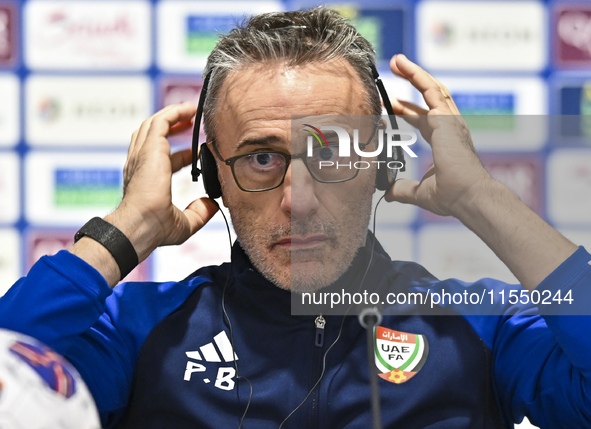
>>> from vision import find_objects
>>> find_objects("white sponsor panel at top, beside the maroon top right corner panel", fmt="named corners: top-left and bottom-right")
top-left (417, 1), bottom-right (546, 71)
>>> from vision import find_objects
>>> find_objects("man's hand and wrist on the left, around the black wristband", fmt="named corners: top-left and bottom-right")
top-left (69, 102), bottom-right (219, 286)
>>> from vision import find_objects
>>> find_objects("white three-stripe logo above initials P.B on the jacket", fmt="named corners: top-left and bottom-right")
top-left (184, 331), bottom-right (238, 390)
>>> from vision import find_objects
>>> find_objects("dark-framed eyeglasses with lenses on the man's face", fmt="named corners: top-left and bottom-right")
top-left (212, 125), bottom-right (378, 192)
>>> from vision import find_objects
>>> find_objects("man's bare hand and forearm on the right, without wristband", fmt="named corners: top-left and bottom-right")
top-left (386, 55), bottom-right (577, 290)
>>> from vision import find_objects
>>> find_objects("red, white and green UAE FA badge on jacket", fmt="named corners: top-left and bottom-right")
top-left (374, 326), bottom-right (429, 384)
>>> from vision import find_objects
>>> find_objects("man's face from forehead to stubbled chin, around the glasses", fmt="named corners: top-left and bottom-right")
top-left (216, 60), bottom-right (375, 292)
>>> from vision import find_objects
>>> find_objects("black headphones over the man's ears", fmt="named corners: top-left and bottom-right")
top-left (191, 62), bottom-right (406, 199)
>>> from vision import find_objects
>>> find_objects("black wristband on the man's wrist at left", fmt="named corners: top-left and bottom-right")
top-left (74, 217), bottom-right (139, 279)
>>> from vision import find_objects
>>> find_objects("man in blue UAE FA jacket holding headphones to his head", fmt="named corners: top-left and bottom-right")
top-left (0, 8), bottom-right (591, 428)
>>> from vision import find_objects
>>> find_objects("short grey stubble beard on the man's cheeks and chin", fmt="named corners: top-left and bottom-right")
top-left (221, 162), bottom-right (375, 293)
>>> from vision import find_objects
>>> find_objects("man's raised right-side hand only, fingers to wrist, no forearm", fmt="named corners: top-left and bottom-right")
top-left (386, 55), bottom-right (492, 216)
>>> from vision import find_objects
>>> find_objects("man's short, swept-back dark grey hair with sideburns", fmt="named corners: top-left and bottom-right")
top-left (203, 7), bottom-right (381, 140)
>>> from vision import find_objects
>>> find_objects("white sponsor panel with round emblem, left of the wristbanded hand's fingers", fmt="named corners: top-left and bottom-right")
top-left (26, 75), bottom-right (152, 146)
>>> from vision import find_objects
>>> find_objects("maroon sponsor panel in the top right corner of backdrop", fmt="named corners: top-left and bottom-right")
top-left (554, 5), bottom-right (591, 66)
